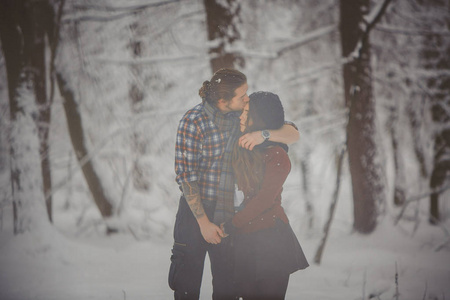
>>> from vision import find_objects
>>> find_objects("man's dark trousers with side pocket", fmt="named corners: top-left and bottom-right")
top-left (169, 197), bottom-right (237, 300)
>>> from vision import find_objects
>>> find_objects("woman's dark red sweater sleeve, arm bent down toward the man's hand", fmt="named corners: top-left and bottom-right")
top-left (232, 147), bottom-right (291, 228)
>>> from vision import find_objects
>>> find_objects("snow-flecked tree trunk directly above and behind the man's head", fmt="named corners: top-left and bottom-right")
top-left (204, 0), bottom-right (245, 72)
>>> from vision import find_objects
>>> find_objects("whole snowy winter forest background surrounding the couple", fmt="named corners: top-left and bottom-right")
top-left (0, 0), bottom-right (450, 300)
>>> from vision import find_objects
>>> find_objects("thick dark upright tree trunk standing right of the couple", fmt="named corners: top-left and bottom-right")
top-left (340, 0), bottom-right (383, 233)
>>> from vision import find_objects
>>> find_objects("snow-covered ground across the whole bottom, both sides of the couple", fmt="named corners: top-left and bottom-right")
top-left (0, 204), bottom-right (450, 300)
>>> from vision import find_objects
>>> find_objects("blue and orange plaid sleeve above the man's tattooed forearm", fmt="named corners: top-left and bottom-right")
top-left (175, 116), bottom-right (203, 185)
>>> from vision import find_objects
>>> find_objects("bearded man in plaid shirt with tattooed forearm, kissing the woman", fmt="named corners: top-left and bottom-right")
top-left (169, 69), bottom-right (299, 300)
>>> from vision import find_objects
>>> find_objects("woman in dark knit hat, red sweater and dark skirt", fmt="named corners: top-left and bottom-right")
top-left (222, 92), bottom-right (308, 300)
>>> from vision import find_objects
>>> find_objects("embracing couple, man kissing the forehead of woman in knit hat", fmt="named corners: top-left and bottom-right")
top-left (169, 69), bottom-right (308, 300)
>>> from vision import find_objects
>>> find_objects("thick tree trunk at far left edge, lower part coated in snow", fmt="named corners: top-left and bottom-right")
top-left (0, 1), bottom-right (51, 234)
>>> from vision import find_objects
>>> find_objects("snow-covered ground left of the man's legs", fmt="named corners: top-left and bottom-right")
top-left (0, 227), bottom-right (170, 300)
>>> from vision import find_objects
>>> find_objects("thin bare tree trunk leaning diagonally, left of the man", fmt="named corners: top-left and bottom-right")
top-left (56, 73), bottom-right (115, 233)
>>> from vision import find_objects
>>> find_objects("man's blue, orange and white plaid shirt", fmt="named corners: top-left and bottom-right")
top-left (175, 104), bottom-right (239, 201)
